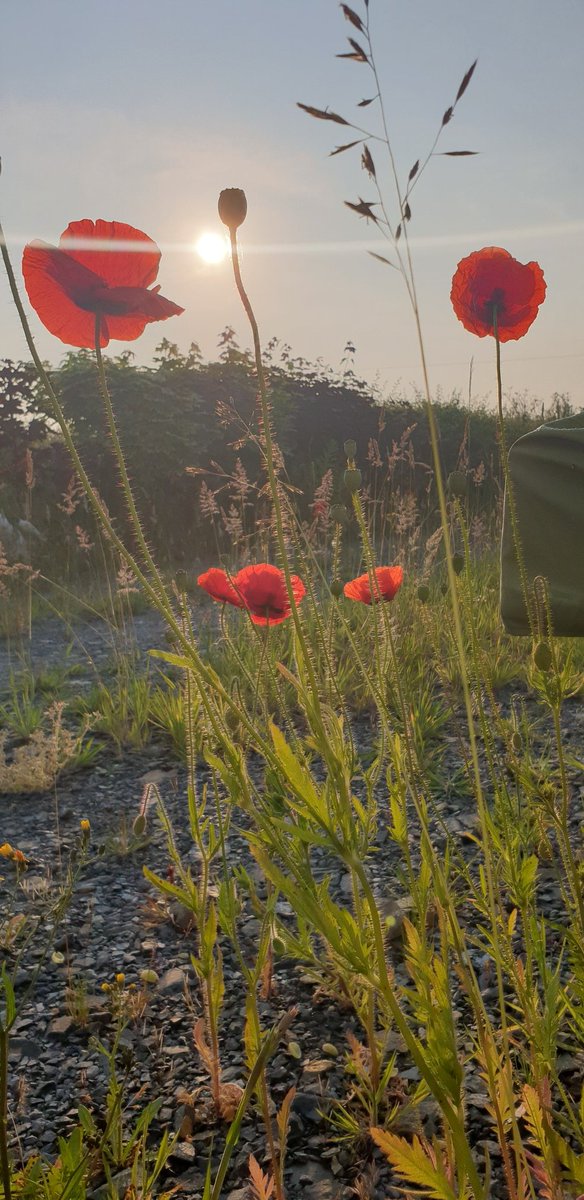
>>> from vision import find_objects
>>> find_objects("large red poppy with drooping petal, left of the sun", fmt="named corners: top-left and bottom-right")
top-left (23, 221), bottom-right (185, 349)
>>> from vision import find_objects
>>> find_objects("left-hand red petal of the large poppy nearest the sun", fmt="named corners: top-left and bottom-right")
top-left (23, 242), bottom-right (109, 349)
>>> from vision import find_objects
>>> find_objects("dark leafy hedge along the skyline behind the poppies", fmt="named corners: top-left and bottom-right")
top-left (0, 348), bottom-right (556, 578)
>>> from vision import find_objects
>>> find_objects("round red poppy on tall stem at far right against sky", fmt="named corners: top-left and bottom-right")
top-left (450, 246), bottom-right (546, 342)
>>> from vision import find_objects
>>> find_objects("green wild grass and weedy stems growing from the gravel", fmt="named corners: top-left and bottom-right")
top-left (0, 4), bottom-right (584, 1200)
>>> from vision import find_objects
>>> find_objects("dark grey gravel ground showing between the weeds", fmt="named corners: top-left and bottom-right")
top-left (0, 613), bottom-right (584, 1200)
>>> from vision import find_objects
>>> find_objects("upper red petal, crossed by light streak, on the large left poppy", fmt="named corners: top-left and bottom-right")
top-left (59, 220), bottom-right (161, 288)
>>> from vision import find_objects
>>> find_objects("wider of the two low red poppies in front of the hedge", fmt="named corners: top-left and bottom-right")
top-left (197, 563), bottom-right (306, 625)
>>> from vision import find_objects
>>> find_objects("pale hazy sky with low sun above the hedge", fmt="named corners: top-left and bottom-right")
top-left (0, 0), bottom-right (584, 407)
